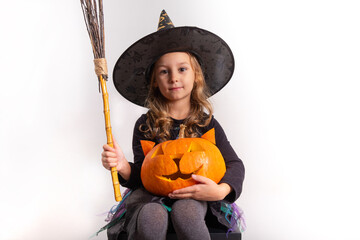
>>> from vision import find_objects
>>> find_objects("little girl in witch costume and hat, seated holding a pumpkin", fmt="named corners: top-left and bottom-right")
top-left (102, 11), bottom-right (244, 240)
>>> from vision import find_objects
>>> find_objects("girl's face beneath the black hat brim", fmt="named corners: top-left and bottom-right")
top-left (154, 52), bottom-right (195, 102)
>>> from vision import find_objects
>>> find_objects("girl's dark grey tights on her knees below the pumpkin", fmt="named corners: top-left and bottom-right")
top-left (134, 199), bottom-right (210, 240)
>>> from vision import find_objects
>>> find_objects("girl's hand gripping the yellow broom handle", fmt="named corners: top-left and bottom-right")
top-left (101, 138), bottom-right (131, 180)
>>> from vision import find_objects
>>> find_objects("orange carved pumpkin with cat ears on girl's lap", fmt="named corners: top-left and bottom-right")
top-left (141, 129), bottom-right (226, 196)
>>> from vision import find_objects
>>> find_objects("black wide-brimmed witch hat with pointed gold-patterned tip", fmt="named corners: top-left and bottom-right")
top-left (113, 10), bottom-right (234, 106)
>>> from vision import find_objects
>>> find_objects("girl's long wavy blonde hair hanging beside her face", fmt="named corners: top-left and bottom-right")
top-left (140, 52), bottom-right (213, 142)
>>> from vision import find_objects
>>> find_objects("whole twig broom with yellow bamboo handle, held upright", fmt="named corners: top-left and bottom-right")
top-left (80, 0), bottom-right (122, 202)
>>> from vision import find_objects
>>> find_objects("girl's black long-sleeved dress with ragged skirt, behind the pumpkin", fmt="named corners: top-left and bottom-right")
top-left (108, 114), bottom-right (245, 239)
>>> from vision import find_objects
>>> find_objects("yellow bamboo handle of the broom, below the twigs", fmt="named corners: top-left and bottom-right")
top-left (99, 75), bottom-right (122, 202)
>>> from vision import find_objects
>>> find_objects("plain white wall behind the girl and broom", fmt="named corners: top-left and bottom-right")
top-left (0, 0), bottom-right (360, 240)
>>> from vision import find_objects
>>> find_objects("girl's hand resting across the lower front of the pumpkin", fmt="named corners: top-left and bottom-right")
top-left (169, 174), bottom-right (232, 201)
